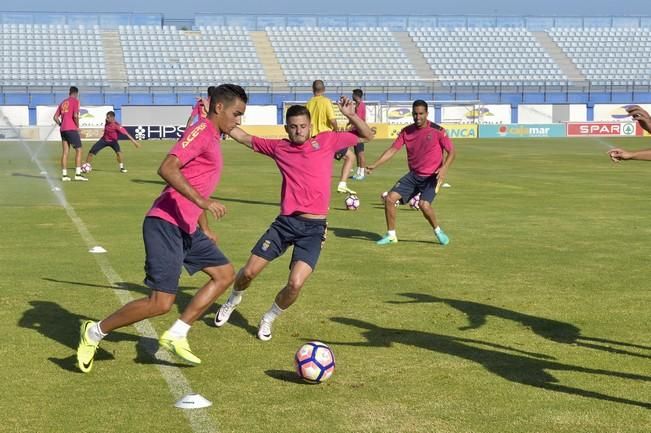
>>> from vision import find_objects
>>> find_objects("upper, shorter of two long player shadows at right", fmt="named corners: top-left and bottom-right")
top-left (389, 293), bottom-right (651, 359)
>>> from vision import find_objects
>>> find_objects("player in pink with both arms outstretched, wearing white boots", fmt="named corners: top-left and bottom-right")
top-left (215, 97), bottom-right (373, 341)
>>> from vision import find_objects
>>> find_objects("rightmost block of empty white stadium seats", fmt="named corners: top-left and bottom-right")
top-left (548, 27), bottom-right (651, 85)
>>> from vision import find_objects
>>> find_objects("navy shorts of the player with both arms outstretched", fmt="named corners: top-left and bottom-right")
top-left (251, 215), bottom-right (327, 270)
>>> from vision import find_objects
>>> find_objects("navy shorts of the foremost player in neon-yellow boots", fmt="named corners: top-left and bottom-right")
top-left (142, 217), bottom-right (230, 294)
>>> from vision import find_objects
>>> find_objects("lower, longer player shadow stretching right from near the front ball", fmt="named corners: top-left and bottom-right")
top-left (331, 317), bottom-right (651, 409)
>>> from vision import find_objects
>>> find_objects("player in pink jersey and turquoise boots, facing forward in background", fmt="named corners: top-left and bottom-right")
top-left (366, 99), bottom-right (456, 245)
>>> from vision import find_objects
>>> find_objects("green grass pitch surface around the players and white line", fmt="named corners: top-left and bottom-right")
top-left (0, 139), bottom-right (651, 433)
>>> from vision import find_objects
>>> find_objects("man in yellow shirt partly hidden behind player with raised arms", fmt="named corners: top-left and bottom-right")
top-left (306, 80), bottom-right (356, 194)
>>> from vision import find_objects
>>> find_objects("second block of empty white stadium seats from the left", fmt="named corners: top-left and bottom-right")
top-left (119, 26), bottom-right (268, 87)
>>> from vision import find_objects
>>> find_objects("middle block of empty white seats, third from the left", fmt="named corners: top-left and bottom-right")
top-left (266, 27), bottom-right (415, 87)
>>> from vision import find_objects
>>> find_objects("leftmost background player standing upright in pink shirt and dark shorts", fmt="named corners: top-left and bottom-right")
top-left (53, 86), bottom-right (88, 182)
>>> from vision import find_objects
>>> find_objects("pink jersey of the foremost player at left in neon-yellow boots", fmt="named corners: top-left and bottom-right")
top-left (147, 119), bottom-right (223, 234)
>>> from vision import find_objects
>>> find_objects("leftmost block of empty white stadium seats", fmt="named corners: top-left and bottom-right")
top-left (0, 24), bottom-right (107, 87)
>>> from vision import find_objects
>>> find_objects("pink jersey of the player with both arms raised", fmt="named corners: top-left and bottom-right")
top-left (252, 131), bottom-right (359, 215)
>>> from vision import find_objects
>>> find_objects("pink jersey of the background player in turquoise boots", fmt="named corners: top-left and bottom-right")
top-left (393, 122), bottom-right (454, 177)
